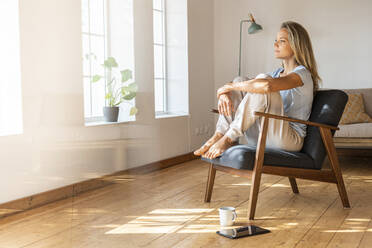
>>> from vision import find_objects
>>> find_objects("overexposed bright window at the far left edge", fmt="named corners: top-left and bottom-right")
top-left (0, 0), bottom-right (23, 136)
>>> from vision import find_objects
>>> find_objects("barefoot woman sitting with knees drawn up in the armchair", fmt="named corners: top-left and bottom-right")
top-left (194, 22), bottom-right (320, 159)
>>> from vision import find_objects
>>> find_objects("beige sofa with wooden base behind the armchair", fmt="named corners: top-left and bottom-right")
top-left (334, 88), bottom-right (372, 148)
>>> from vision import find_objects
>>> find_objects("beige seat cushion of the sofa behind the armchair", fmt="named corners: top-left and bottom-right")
top-left (335, 123), bottom-right (372, 138)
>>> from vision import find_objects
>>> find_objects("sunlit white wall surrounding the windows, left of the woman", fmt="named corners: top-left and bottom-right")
top-left (0, 0), bottom-right (214, 203)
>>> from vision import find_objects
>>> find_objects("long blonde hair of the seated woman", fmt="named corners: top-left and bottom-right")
top-left (280, 21), bottom-right (322, 94)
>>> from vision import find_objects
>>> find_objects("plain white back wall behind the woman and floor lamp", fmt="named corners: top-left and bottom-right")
top-left (214, 0), bottom-right (372, 91)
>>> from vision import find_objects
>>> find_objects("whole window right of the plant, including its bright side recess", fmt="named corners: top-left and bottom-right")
top-left (153, 0), bottom-right (189, 118)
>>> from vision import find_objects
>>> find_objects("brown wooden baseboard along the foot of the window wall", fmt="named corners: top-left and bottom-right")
top-left (0, 153), bottom-right (197, 218)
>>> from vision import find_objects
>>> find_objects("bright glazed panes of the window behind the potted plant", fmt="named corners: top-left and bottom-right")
top-left (82, 0), bottom-right (107, 119)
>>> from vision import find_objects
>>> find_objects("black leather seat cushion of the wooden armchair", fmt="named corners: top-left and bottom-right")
top-left (202, 145), bottom-right (315, 170)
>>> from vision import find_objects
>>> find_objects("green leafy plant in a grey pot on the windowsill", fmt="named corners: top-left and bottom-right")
top-left (92, 57), bottom-right (138, 122)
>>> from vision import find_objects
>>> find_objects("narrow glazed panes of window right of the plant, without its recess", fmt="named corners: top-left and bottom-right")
top-left (153, 0), bottom-right (167, 114)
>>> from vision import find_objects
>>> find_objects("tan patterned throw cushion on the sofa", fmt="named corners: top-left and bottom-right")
top-left (340, 93), bottom-right (372, 124)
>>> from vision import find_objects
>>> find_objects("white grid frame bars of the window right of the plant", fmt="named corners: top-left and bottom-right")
top-left (153, 0), bottom-right (168, 116)
